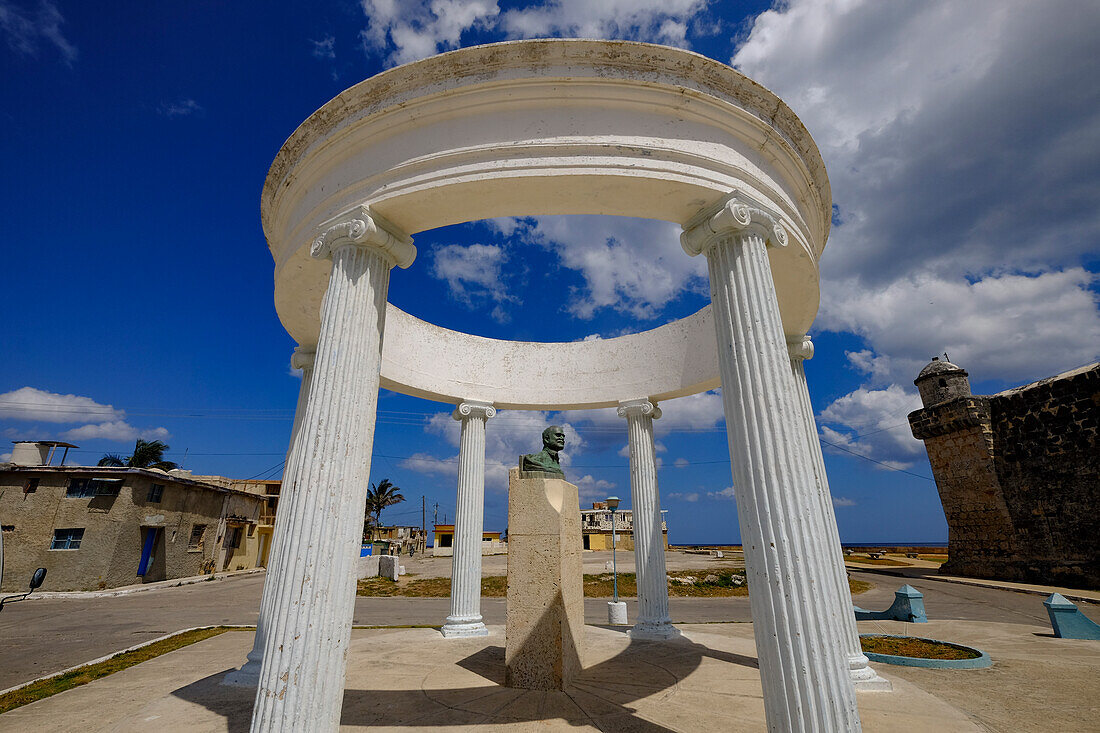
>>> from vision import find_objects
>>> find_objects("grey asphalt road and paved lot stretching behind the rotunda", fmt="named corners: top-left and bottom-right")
top-left (0, 553), bottom-right (1082, 689)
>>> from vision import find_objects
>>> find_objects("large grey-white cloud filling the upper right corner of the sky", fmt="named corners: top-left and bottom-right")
top-left (733, 0), bottom-right (1100, 283)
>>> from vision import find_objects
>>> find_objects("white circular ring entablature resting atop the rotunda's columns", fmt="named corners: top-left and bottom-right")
top-left (261, 40), bottom-right (832, 408)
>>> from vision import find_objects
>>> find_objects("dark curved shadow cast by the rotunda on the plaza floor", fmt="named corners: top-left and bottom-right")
top-left (172, 636), bottom-right (759, 733)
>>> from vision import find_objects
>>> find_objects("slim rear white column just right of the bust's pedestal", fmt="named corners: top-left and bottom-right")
top-left (618, 400), bottom-right (680, 638)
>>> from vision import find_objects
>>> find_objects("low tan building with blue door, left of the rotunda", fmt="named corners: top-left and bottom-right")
top-left (0, 444), bottom-right (274, 592)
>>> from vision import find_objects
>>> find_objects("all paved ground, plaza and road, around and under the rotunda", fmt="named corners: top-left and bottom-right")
top-left (0, 553), bottom-right (1100, 733)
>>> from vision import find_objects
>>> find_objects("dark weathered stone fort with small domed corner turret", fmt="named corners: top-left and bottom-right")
top-left (909, 354), bottom-right (1100, 588)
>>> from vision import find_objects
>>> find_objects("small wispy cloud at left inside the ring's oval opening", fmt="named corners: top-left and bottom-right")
top-left (431, 244), bottom-right (518, 322)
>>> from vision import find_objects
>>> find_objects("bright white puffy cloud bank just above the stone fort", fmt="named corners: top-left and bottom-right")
top-left (817, 267), bottom-right (1100, 384)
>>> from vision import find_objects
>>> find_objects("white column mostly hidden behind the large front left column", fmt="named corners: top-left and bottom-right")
top-left (222, 346), bottom-right (315, 687)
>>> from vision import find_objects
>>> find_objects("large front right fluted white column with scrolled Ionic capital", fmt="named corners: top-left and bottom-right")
top-left (681, 197), bottom-right (860, 733)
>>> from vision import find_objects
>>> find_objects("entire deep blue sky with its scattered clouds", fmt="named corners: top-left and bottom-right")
top-left (0, 0), bottom-right (1100, 543)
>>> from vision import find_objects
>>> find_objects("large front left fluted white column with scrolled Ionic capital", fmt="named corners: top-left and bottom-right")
top-left (252, 207), bottom-right (416, 733)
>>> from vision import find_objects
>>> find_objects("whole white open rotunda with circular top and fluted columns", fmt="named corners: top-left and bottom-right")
top-left (245, 40), bottom-right (884, 732)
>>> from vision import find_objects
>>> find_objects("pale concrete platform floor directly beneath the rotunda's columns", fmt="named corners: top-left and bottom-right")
top-left (0, 624), bottom-right (1007, 733)
